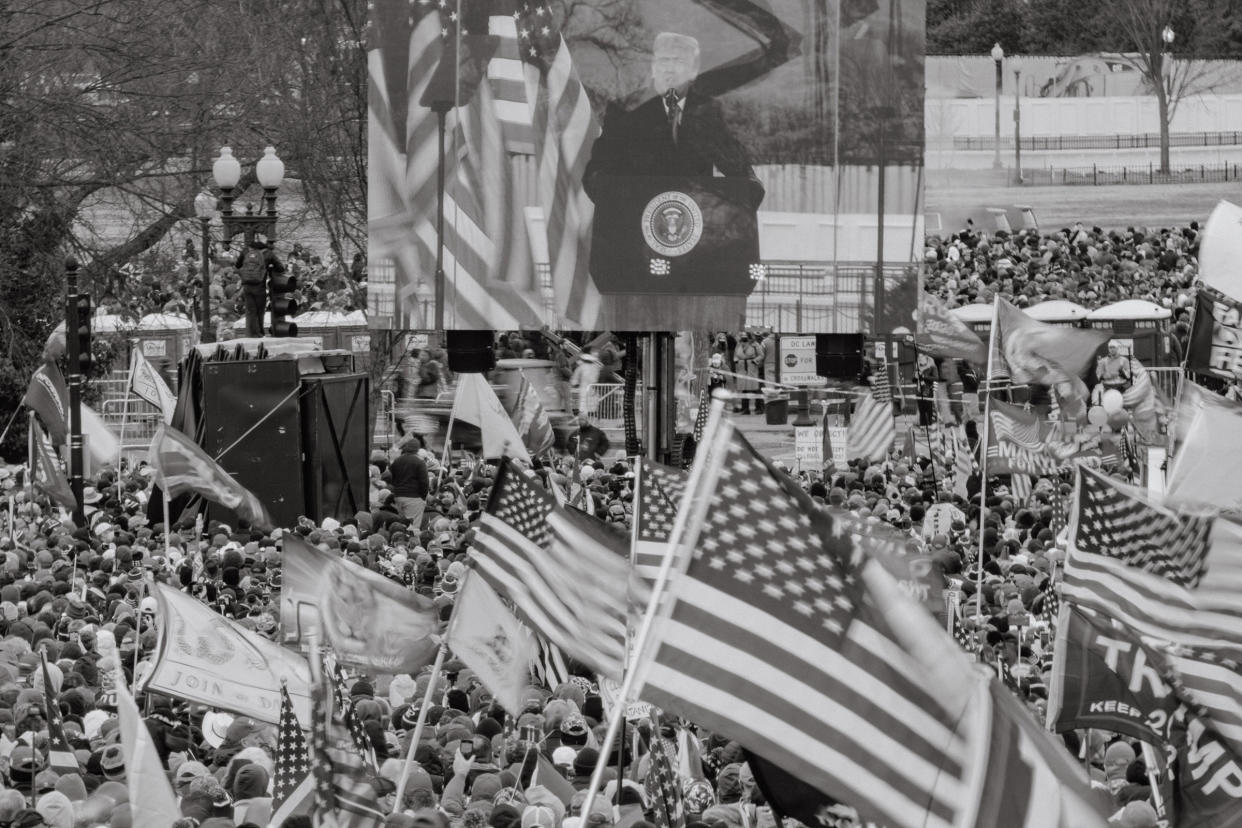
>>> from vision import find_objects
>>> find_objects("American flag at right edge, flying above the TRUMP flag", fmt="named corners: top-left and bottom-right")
top-left (1061, 467), bottom-right (1242, 749)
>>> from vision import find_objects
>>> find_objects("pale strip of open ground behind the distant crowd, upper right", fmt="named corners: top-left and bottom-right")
top-left (925, 173), bottom-right (1242, 232)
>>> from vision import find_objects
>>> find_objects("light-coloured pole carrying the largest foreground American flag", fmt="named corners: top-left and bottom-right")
top-left (581, 390), bottom-right (733, 821)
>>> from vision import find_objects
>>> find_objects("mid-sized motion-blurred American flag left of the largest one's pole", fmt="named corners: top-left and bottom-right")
top-left (469, 458), bottom-right (641, 678)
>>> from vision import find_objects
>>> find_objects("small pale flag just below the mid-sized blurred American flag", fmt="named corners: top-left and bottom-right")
top-left (447, 572), bottom-right (535, 716)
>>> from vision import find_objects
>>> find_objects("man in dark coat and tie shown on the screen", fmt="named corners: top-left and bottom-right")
top-left (582, 32), bottom-right (764, 210)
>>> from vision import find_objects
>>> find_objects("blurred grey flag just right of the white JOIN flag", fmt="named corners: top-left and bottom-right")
top-left (281, 533), bottom-right (440, 673)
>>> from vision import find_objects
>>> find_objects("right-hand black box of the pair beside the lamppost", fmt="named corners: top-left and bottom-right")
top-left (299, 374), bottom-right (370, 523)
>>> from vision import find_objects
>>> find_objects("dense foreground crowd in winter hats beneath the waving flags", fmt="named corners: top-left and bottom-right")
top-left (0, 407), bottom-right (1155, 828)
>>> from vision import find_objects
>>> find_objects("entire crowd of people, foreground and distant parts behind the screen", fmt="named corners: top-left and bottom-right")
top-left (0, 223), bottom-right (1199, 828)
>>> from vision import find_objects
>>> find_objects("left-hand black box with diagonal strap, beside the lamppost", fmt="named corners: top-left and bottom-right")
top-left (202, 360), bottom-right (306, 526)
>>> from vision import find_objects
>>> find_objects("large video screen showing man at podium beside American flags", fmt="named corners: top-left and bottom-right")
top-left (366, 0), bottom-right (924, 333)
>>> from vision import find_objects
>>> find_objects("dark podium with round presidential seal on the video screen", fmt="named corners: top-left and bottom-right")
top-left (590, 175), bottom-right (760, 330)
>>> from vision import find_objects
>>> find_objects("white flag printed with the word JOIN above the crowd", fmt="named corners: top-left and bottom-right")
top-left (143, 583), bottom-right (311, 726)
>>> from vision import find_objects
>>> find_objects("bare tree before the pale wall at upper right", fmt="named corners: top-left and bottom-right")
top-left (1109, 0), bottom-right (1228, 174)
